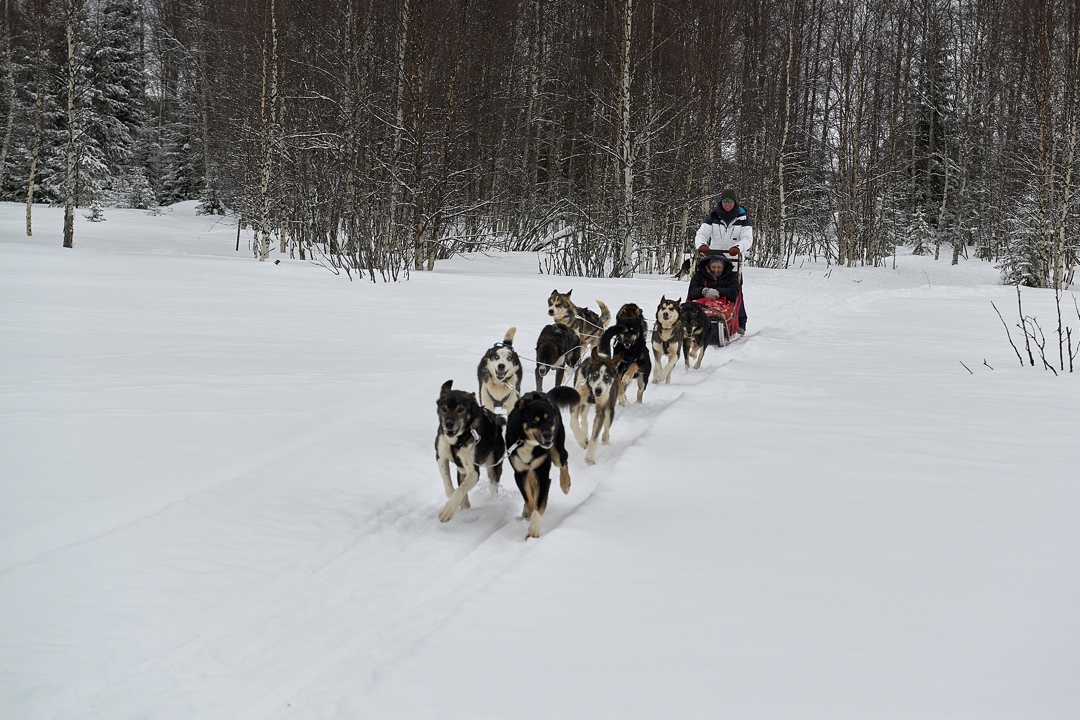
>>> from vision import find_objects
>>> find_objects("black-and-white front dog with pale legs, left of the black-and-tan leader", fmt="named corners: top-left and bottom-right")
top-left (435, 380), bottom-right (507, 522)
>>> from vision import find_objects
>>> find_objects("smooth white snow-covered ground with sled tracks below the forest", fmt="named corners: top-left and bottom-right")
top-left (0, 204), bottom-right (1080, 720)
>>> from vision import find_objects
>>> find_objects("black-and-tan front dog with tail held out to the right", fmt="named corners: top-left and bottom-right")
top-left (507, 385), bottom-right (579, 540)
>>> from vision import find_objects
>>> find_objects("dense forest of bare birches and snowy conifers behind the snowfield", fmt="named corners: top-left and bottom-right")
top-left (0, 0), bottom-right (1080, 288)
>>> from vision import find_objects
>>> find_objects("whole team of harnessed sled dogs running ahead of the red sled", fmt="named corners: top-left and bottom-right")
top-left (435, 289), bottom-right (710, 538)
